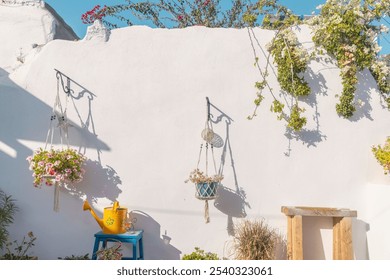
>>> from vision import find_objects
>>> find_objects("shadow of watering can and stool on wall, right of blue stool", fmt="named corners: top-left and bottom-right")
top-left (130, 210), bottom-right (181, 260)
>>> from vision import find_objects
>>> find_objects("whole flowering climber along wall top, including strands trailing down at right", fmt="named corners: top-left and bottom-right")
top-left (82, 0), bottom-right (390, 131)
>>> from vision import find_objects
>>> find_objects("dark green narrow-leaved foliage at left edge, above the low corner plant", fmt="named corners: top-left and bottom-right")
top-left (0, 190), bottom-right (18, 250)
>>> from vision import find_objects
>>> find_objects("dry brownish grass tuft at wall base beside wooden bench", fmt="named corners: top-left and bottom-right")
top-left (233, 220), bottom-right (278, 260)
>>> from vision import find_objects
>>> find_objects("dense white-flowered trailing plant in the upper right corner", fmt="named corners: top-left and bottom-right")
top-left (310, 0), bottom-right (390, 118)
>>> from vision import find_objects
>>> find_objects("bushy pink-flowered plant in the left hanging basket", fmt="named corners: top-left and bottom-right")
top-left (27, 148), bottom-right (86, 187)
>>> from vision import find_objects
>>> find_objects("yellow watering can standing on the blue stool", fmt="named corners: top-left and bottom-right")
top-left (83, 200), bottom-right (127, 234)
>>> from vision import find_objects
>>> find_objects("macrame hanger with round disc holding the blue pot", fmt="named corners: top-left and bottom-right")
top-left (195, 97), bottom-right (219, 223)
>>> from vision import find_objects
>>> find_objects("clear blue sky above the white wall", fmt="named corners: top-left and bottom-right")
top-left (45, 0), bottom-right (390, 54)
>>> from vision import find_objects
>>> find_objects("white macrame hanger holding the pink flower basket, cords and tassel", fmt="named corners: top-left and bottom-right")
top-left (45, 70), bottom-right (69, 212)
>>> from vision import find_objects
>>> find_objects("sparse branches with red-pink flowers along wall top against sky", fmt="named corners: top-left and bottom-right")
top-left (92, 0), bottom-right (259, 28)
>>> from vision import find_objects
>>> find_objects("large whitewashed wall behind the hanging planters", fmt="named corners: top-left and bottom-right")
top-left (0, 8), bottom-right (390, 259)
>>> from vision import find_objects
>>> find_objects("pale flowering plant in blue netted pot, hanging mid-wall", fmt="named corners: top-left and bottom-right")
top-left (186, 168), bottom-right (223, 199)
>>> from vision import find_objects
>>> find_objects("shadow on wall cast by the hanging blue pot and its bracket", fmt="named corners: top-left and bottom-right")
top-left (210, 100), bottom-right (250, 235)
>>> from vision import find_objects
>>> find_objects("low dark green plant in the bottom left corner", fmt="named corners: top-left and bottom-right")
top-left (1, 231), bottom-right (37, 260)
